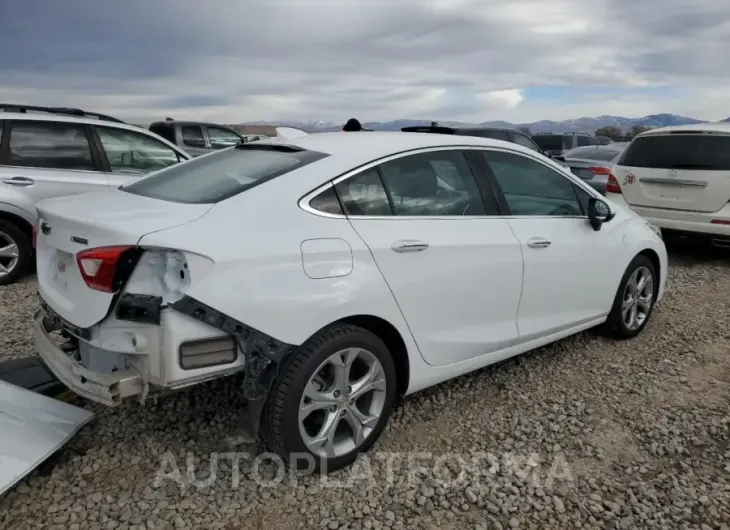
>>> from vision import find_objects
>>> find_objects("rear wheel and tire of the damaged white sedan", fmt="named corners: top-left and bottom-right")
top-left (264, 324), bottom-right (396, 473)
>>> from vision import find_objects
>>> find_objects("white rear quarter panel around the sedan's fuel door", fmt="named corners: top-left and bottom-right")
top-left (140, 182), bottom-right (417, 351)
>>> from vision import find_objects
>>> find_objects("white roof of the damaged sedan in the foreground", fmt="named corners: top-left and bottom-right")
top-left (257, 131), bottom-right (535, 167)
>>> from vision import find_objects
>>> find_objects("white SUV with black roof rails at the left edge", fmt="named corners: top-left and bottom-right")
top-left (0, 104), bottom-right (190, 285)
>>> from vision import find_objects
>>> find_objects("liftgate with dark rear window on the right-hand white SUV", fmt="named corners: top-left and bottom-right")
top-left (614, 131), bottom-right (730, 212)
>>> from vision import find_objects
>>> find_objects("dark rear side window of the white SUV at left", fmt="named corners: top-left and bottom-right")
top-left (8, 121), bottom-right (94, 170)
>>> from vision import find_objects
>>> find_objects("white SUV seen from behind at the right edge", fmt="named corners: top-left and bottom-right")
top-left (606, 123), bottom-right (730, 247)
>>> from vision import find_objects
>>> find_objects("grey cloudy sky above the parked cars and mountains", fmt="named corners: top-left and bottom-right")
top-left (0, 0), bottom-right (730, 123)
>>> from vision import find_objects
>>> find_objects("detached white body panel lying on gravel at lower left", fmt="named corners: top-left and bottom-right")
top-left (0, 381), bottom-right (94, 495)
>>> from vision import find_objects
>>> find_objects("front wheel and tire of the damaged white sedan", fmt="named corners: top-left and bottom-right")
top-left (604, 255), bottom-right (659, 339)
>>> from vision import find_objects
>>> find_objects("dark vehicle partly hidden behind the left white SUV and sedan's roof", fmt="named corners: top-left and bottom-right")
top-left (150, 118), bottom-right (246, 156)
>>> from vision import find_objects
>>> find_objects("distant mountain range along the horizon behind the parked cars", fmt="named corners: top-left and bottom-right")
top-left (244, 114), bottom-right (730, 134)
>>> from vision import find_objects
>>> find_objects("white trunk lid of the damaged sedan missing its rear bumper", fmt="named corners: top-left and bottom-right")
top-left (36, 190), bottom-right (212, 328)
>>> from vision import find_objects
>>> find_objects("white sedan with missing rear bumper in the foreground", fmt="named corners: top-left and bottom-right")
top-left (33, 132), bottom-right (667, 471)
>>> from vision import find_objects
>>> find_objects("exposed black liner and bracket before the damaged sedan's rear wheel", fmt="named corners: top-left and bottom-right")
top-left (170, 296), bottom-right (296, 440)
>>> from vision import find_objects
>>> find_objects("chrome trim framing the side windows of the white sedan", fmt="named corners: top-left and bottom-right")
top-left (299, 145), bottom-right (606, 221)
